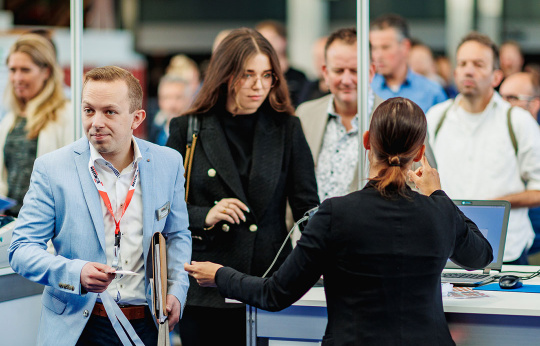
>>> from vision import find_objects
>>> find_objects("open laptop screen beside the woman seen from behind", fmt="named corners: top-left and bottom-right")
top-left (445, 200), bottom-right (510, 270)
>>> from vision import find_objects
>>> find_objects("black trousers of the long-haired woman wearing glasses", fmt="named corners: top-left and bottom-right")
top-left (178, 305), bottom-right (246, 346)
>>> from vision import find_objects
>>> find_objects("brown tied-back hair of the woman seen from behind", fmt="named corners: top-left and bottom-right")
top-left (369, 97), bottom-right (427, 196)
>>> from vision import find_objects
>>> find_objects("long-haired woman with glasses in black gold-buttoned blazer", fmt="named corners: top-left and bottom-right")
top-left (167, 28), bottom-right (319, 346)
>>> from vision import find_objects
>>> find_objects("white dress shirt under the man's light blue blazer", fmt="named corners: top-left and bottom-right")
top-left (90, 139), bottom-right (146, 305)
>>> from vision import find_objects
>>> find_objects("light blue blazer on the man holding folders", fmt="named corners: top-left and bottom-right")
top-left (9, 138), bottom-right (191, 346)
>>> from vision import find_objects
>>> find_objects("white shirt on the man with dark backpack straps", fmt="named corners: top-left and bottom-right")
top-left (426, 92), bottom-right (540, 262)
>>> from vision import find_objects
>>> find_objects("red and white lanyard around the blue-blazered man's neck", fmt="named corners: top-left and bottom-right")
top-left (88, 160), bottom-right (139, 269)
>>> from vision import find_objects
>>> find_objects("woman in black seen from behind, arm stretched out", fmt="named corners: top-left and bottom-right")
top-left (184, 98), bottom-right (493, 346)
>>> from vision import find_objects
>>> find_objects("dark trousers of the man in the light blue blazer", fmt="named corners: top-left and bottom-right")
top-left (76, 307), bottom-right (158, 346)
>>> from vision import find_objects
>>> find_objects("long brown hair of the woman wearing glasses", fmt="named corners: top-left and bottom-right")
top-left (184, 28), bottom-right (294, 114)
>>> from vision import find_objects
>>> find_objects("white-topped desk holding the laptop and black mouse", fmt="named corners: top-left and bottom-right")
top-left (246, 266), bottom-right (540, 346)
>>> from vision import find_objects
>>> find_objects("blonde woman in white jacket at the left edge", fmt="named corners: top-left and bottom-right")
top-left (0, 34), bottom-right (74, 216)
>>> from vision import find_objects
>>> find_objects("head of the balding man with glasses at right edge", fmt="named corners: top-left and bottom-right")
top-left (499, 72), bottom-right (540, 120)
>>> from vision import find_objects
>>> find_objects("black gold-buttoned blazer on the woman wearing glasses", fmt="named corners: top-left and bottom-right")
top-left (167, 107), bottom-right (319, 307)
